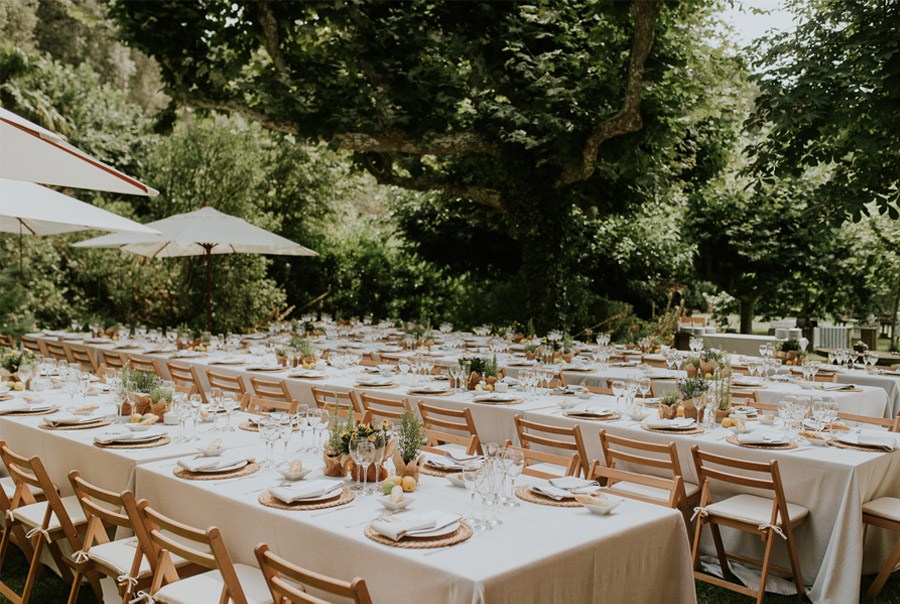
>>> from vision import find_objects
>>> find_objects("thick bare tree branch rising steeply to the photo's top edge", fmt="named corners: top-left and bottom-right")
top-left (556, 0), bottom-right (660, 187)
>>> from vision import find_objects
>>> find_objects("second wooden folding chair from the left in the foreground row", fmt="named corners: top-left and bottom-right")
top-left (69, 470), bottom-right (198, 604)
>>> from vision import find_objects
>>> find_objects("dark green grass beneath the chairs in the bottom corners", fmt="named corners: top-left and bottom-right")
top-left (0, 548), bottom-right (900, 604)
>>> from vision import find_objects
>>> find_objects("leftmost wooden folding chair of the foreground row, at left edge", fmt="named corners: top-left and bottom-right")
top-left (0, 441), bottom-right (103, 604)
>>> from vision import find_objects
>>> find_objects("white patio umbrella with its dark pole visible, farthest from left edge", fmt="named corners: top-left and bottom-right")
top-left (73, 206), bottom-right (318, 330)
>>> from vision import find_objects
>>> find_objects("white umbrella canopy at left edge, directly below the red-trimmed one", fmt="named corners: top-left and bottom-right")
top-left (0, 178), bottom-right (159, 235)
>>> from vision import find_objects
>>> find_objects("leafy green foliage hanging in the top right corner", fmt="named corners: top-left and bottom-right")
top-left (751, 0), bottom-right (900, 225)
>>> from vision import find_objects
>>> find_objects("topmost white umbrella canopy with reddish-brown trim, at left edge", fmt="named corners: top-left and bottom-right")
top-left (0, 108), bottom-right (159, 197)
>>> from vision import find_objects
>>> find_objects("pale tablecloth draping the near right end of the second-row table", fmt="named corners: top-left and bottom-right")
top-left (527, 397), bottom-right (900, 604)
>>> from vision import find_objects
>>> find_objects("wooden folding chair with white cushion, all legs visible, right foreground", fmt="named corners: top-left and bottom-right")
top-left (691, 445), bottom-right (809, 604)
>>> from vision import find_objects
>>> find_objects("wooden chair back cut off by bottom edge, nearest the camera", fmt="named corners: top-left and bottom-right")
top-left (253, 543), bottom-right (372, 604)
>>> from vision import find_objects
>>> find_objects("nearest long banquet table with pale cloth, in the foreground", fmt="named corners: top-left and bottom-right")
top-left (0, 391), bottom-right (695, 603)
